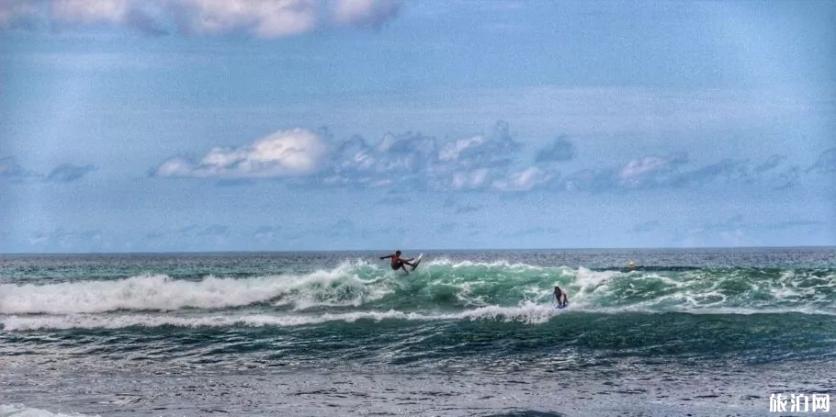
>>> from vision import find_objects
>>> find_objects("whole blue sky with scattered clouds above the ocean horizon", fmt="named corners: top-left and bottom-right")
top-left (0, 0), bottom-right (836, 253)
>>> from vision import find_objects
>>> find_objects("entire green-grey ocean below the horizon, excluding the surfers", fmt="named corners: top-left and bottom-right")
top-left (0, 248), bottom-right (836, 417)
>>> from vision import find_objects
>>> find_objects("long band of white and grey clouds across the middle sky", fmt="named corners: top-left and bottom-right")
top-left (152, 121), bottom-right (824, 194)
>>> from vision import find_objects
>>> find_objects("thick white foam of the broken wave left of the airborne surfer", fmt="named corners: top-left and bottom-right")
top-left (0, 263), bottom-right (391, 314)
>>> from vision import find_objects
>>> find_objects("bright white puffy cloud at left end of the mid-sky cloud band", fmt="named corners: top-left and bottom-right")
top-left (152, 128), bottom-right (327, 178)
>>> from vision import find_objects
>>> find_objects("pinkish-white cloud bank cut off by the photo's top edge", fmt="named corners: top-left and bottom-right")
top-left (0, 0), bottom-right (401, 39)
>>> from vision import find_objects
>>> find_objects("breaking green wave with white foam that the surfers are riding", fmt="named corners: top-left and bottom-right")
top-left (0, 259), bottom-right (836, 315)
